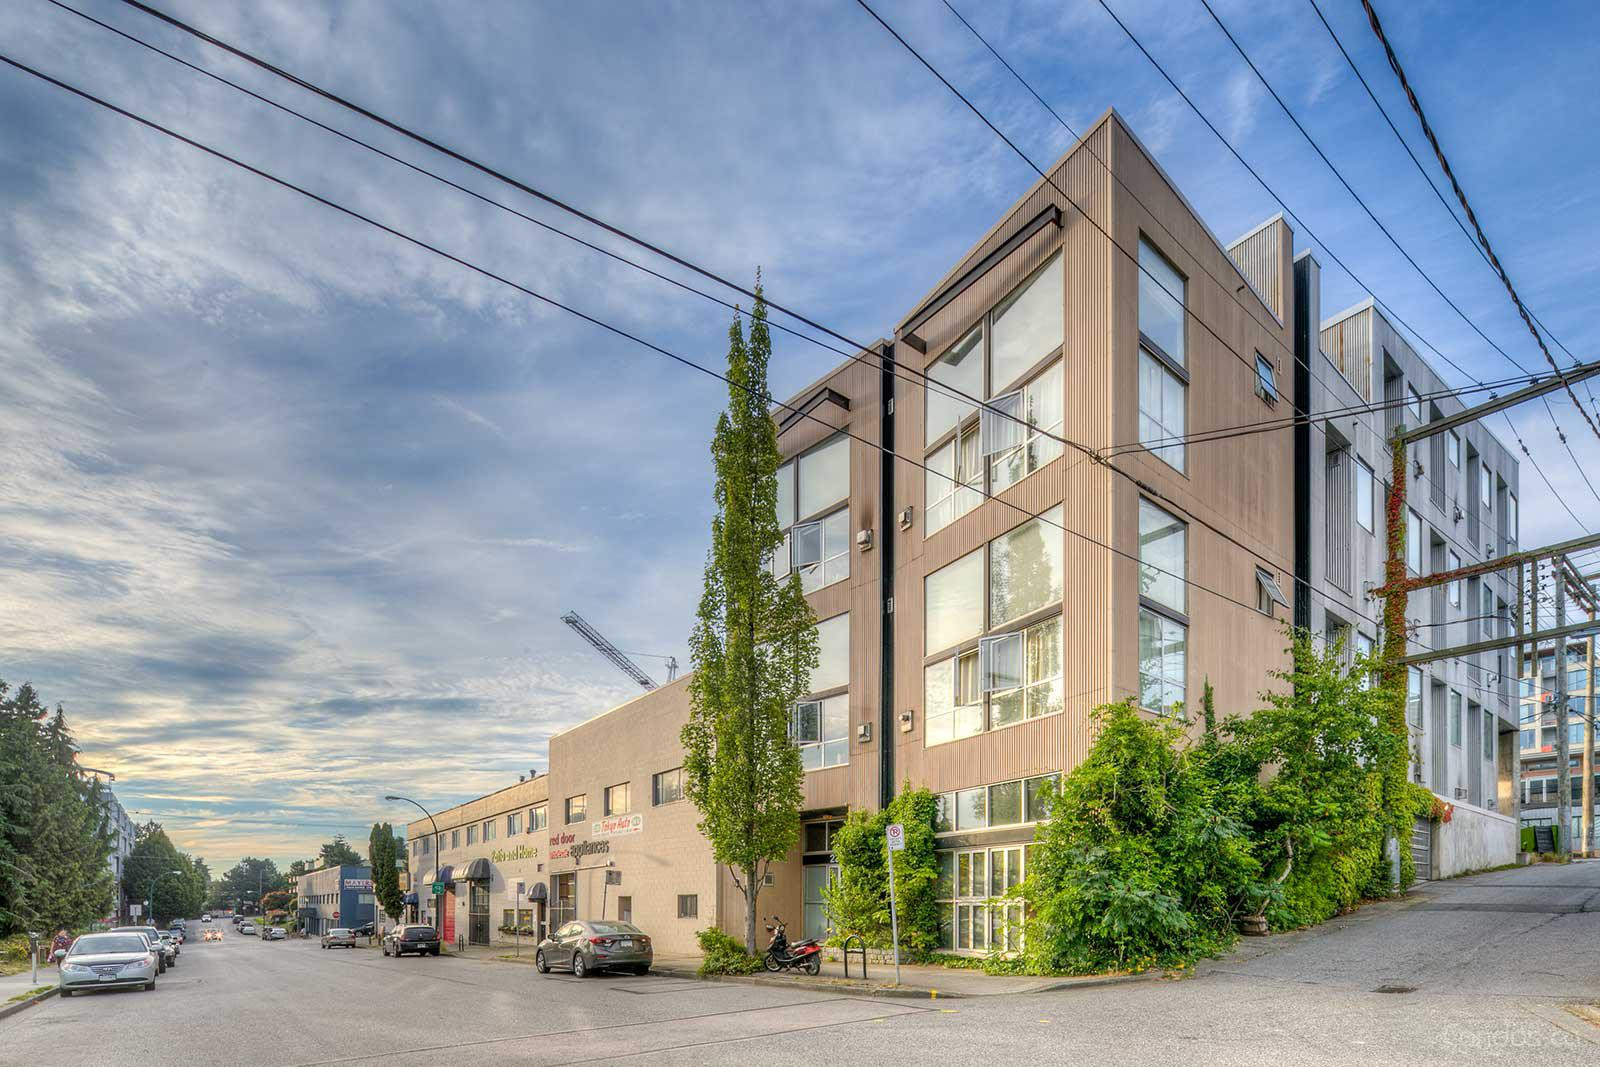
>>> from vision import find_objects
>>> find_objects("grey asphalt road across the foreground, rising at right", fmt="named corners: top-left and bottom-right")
top-left (0, 862), bottom-right (1600, 1067)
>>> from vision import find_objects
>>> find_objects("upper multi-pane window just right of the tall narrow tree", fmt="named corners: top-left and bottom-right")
top-left (773, 434), bottom-right (850, 592)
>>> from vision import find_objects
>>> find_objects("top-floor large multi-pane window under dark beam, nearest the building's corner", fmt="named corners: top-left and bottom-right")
top-left (923, 256), bottom-right (1066, 534)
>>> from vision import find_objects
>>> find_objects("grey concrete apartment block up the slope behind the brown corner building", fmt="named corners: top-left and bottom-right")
top-left (1294, 253), bottom-right (1518, 878)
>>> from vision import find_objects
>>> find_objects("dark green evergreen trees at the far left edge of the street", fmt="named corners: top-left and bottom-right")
top-left (0, 681), bottom-right (115, 934)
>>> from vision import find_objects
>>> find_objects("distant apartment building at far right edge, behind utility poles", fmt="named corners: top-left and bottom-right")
top-left (1518, 637), bottom-right (1600, 848)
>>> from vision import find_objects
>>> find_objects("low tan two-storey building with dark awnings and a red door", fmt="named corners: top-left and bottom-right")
top-left (405, 774), bottom-right (549, 945)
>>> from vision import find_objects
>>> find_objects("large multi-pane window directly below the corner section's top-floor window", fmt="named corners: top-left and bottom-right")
top-left (923, 507), bottom-right (1062, 745)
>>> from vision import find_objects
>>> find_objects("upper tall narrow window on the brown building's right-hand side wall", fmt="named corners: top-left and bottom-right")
top-left (1139, 238), bottom-right (1189, 470)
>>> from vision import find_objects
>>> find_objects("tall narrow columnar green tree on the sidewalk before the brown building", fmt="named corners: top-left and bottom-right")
top-left (683, 282), bottom-right (818, 952)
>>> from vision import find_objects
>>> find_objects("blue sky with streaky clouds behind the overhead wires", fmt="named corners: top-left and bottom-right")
top-left (0, 0), bottom-right (1600, 872)
